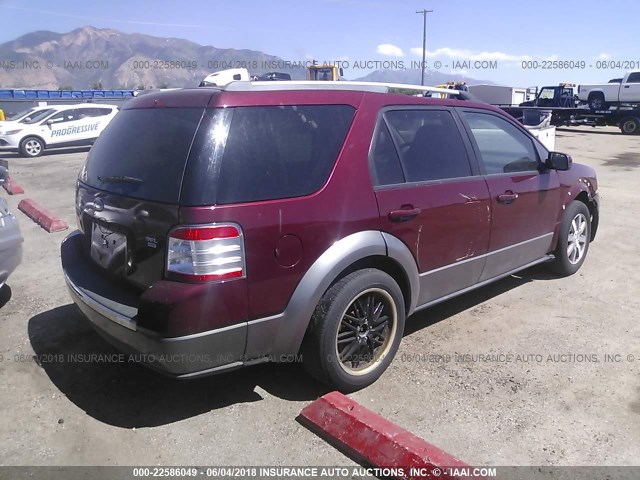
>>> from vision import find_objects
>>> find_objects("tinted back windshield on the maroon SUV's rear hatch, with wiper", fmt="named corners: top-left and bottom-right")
top-left (80, 108), bottom-right (204, 203)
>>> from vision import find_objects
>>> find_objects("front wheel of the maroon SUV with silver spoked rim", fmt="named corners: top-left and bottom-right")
top-left (550, 200), bottom-right (591, 277)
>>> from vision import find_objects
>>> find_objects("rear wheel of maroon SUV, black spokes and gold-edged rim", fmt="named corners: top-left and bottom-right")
top-left (301, 268), bottom-right (405, 392)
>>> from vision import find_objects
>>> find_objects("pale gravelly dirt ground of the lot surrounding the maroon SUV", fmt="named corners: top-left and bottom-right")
top-left (0, 127), bottom-right (640, 465)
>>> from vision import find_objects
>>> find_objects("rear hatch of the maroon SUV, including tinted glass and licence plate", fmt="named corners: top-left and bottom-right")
top-left (76, 91), bottom-right (210, 289)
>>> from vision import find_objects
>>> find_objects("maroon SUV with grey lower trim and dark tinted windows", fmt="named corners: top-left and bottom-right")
top-left (62, 83), bottom-right (598, 390)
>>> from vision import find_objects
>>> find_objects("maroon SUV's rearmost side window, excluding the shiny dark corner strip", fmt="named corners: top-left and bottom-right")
top-left (217, 105), bottom-right (354, 204)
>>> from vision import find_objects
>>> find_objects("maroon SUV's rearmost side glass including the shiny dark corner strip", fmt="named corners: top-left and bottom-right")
top-left (180, 105), bottom-right (355, 205)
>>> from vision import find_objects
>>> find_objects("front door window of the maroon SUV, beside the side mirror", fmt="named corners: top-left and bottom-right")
top-left (464, 112), bottom-right (539, 175)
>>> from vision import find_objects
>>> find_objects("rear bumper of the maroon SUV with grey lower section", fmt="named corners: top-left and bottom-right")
top-left (62, 232), bottom-right (247, 378)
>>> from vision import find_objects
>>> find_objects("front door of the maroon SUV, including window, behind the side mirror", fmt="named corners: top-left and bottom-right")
top-left (462, 109), bottom-right (561, 280)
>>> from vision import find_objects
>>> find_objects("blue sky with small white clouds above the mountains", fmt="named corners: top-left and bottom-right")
top-left (0, 0), bottom-right (640, 87)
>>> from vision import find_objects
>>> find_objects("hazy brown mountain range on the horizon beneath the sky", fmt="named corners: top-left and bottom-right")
top-left (0, 26), bottom-right (492, 90)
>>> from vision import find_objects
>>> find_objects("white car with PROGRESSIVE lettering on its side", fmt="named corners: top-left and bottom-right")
top-left (0, 103), bottom-right (118, 157)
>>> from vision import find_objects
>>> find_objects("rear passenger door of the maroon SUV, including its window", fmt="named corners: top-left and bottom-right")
top-left (370, 107), bottom-right (490, 305)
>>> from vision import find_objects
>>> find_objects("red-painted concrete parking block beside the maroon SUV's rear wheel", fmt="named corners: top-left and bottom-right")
top-left (300, 392), bottom-right (469, 479)
